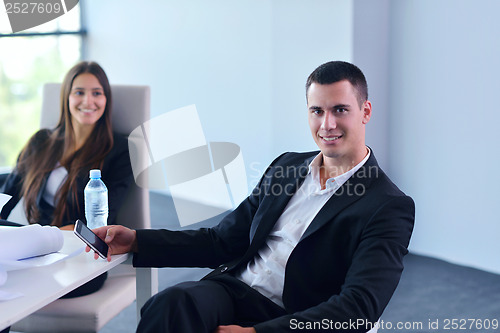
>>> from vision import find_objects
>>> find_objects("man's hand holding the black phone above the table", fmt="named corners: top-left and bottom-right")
top-left (85, 225), bottom-right (137, 261)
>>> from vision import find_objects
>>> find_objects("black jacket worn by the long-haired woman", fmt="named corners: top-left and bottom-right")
top-left (0, 129), bottom-right (133, 226)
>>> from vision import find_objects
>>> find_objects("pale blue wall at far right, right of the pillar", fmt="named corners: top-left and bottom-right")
top-left (389, 0), bottom-right (500, 273)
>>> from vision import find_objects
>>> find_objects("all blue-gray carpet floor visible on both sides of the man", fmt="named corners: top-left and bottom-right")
top-left (94, 193), bottom-right (500, 333)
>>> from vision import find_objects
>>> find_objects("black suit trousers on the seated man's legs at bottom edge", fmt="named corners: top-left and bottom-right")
top-left (137, 274), bottom-right (286, 333)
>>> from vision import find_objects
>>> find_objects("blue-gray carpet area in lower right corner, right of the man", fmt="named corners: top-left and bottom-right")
top-left (379, 254), bottom-right (500, 333)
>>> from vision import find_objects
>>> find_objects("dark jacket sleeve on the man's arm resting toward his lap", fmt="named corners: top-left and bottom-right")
top-left (255, 196), bottom-right (415, 333)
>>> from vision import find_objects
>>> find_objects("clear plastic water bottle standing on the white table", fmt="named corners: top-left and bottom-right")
top-left (83, 169), bottom-right (109, 229)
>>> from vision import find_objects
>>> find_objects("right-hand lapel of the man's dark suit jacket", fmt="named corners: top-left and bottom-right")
top-left (299, 151), bottom-right (381, 242)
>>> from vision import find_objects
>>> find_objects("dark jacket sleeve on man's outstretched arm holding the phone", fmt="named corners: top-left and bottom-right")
top-left (134, 155), bottom-right (290, 268)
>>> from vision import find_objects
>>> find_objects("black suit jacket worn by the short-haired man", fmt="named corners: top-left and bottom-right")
top-left (134, 152), bottom-right (415, 332)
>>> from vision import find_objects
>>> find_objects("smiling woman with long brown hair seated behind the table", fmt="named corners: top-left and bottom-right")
top-left (0, 62), bottom-right (133, 297)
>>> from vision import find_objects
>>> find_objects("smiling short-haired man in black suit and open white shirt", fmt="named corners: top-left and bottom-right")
top-left (92, 61), bottom-right (415, 333)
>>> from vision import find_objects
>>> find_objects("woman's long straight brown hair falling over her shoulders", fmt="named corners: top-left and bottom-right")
top-left (17, 61), bottom-right (113, 226)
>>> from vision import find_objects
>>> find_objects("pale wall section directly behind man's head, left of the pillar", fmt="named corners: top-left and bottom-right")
top-left (265, 0), bottom-right (353, 157)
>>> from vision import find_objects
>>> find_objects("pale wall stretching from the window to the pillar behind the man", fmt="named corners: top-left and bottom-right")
top-left (85, 0), bottom-right (352, 185)
